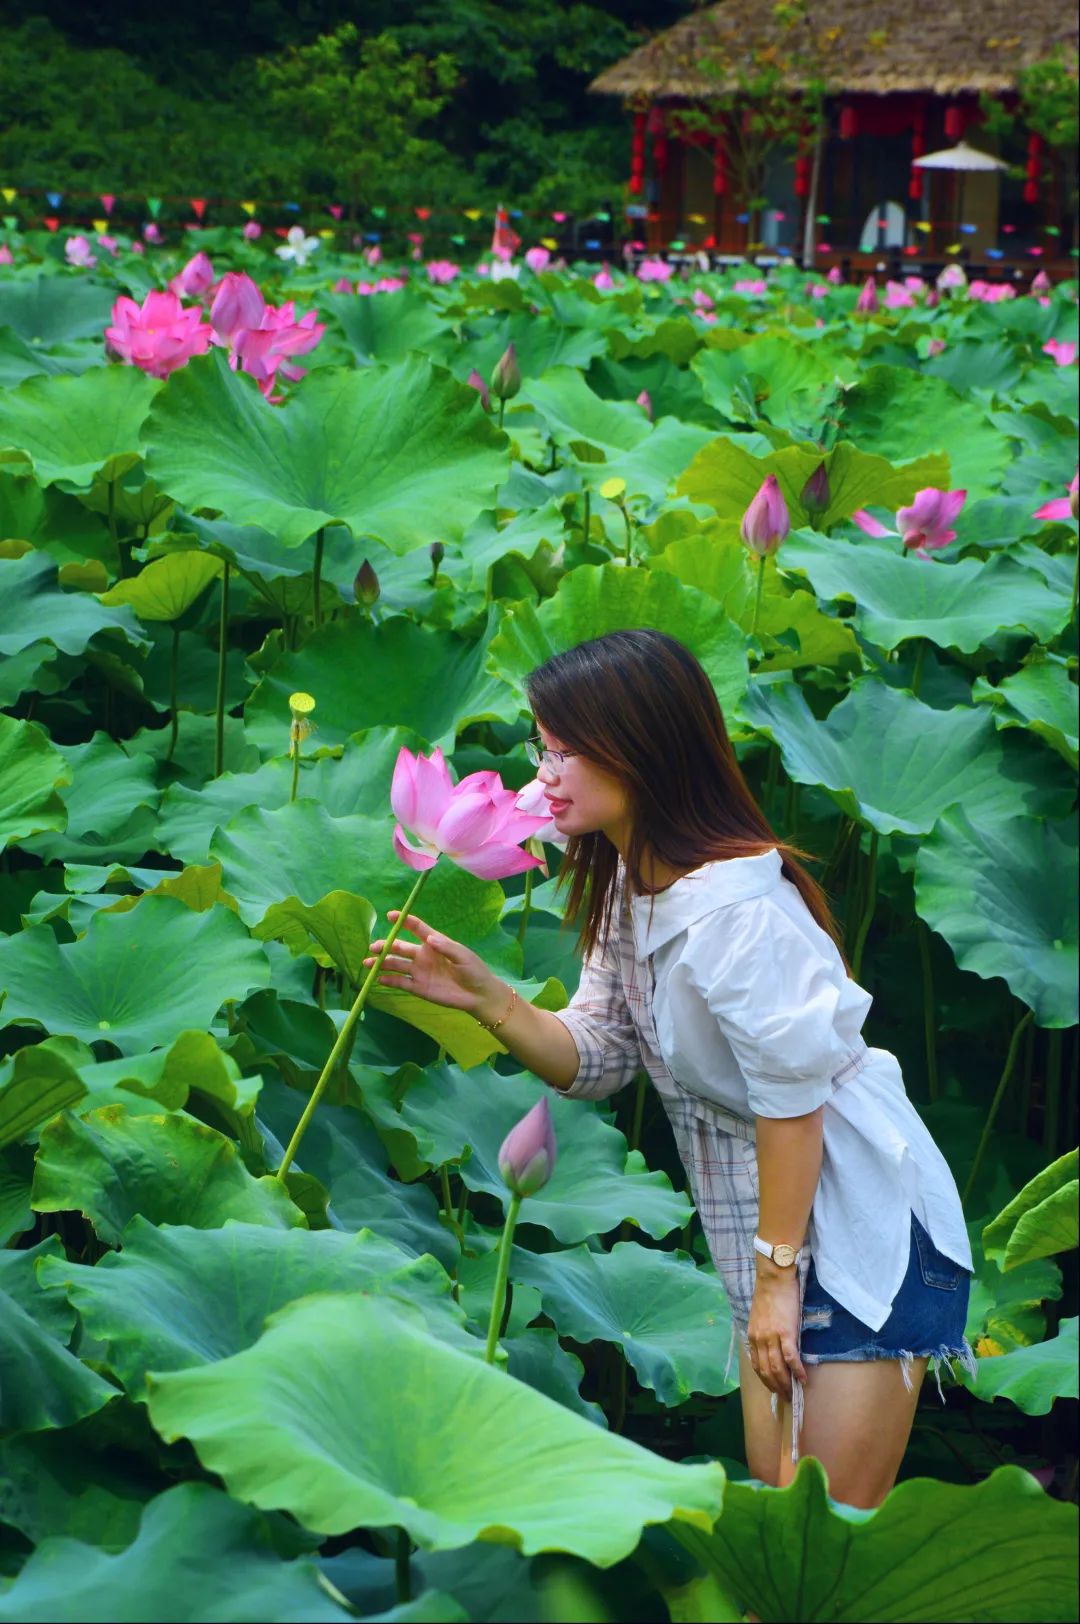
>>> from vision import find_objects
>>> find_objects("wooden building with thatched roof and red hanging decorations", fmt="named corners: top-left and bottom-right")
top-left (590, 0), bottom-right (1077, 274)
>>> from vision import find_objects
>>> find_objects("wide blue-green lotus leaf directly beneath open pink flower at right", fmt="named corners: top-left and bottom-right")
top-left (778, 534), bottom-right (1072, 653)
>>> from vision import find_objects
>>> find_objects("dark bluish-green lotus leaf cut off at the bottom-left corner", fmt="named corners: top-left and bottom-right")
top-left (0, 1483), bottom-right (352, 1624)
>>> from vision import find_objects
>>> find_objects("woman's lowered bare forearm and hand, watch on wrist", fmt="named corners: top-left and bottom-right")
top-left (747, 1106), bottom-right (825, 1400)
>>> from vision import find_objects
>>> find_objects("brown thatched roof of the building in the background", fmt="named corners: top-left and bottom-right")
top-left (590, 0), bottom-right (1077, 101)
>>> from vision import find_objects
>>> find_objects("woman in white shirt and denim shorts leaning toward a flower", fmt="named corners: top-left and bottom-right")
top-left (369, 630), bottom-right (973, 1507)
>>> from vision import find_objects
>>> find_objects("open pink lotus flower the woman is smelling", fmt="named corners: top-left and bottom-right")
top-left (390, 747), bottom-right (544, 880)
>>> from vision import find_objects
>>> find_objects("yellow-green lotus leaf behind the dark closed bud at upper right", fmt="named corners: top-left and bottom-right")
top-left (676, 438), bottom-right (948, 529)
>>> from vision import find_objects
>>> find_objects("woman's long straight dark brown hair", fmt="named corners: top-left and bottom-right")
top-left (525, 628), bottom-right (843, 953)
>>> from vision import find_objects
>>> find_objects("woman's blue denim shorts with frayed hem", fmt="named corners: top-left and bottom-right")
top-left (799, 1213), bottom-right (974, 1392)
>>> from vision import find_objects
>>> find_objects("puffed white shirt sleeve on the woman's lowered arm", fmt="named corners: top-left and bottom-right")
top-left (692, 898), bottom-right (853, 1117)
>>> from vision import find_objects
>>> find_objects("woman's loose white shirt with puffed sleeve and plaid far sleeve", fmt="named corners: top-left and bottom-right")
top-left (560, 849), bottom-right (971, 1330)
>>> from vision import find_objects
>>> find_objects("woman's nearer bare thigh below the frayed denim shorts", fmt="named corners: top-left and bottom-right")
top-left (776, 1359), bottom-right (929, 1509)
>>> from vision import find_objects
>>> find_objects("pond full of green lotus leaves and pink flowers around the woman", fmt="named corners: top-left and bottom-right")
top-left (0, 232), bottom-right (1078, 1621)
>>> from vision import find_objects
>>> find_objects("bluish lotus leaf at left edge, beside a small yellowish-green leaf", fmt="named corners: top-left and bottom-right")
top-left (0, 552), bottom-right (148, 656)
